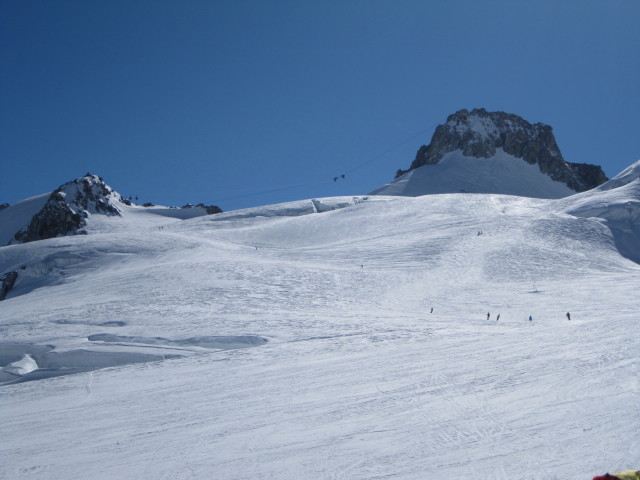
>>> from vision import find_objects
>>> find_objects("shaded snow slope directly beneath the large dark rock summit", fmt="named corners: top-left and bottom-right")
top-left (371, 148), bottom-right (575, 198)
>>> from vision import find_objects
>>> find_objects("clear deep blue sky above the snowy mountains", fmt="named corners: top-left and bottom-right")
top-left (0, 0), bottom-right (640, 210)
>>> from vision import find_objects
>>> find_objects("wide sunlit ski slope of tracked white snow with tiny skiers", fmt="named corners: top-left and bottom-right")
top-left (0, 187), bottom-right (640, 480)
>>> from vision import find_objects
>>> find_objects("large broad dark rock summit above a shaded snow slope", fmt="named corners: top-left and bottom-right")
top-left (396, 108), bottom-right (607, 192)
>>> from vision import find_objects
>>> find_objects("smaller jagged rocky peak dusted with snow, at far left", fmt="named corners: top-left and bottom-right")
top-left (14, 174), bottom-right (126, 243)
